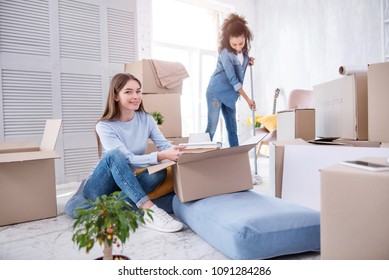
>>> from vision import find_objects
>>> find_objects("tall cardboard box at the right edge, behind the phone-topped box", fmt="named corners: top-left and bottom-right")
top-left (367, 62), bottom-right (389, 142)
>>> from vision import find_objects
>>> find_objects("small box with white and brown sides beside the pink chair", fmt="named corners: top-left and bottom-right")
top-left (277, 109), bottom-right (315, 141)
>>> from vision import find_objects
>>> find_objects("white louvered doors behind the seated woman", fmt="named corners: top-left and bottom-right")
top-left (0, 0), bottom-right (136, 183)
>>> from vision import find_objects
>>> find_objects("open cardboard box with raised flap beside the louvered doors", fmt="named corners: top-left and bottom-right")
top-left (0, 120), bottom-right (61, 226)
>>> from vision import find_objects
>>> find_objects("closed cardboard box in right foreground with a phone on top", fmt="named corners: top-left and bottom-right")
top-left (320, 157), bottom-right (389, 260)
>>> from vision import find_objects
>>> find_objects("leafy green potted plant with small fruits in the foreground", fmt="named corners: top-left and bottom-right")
top-left (72, 192), bottom-right (152, 260)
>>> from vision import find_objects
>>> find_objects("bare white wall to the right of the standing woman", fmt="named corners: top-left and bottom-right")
top-left (255, 0), bottom-right (383, 112)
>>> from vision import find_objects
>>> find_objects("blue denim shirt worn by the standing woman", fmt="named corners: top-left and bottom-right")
top-left (207, 48), bottom-right (249, 109)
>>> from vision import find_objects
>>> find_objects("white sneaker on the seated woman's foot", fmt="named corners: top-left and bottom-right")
top-left (143, 205), bottom-right (183, 232)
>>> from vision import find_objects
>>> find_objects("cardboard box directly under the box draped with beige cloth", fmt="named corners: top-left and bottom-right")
top-left (143, 94), bottom-right (182, 138)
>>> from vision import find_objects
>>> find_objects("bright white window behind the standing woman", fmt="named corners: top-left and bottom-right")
top-left (152, 0), bottom-right (229, 141)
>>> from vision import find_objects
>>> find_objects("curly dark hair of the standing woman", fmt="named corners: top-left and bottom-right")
top-left (218, 13), bottom-right (253, 53)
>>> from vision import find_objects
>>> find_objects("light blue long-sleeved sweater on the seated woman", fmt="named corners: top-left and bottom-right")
top-left (92, 111), bottom-right (172, 171)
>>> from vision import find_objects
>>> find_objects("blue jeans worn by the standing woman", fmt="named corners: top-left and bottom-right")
top-left (205, 92), bottom-right (239, 147)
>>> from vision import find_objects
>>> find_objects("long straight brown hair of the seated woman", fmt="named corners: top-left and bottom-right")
top-left (95, 73), bottom-right (146, 158)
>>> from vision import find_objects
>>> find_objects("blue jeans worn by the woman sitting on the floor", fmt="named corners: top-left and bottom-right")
top-left (83, 149), bottom-right (166, 207)
